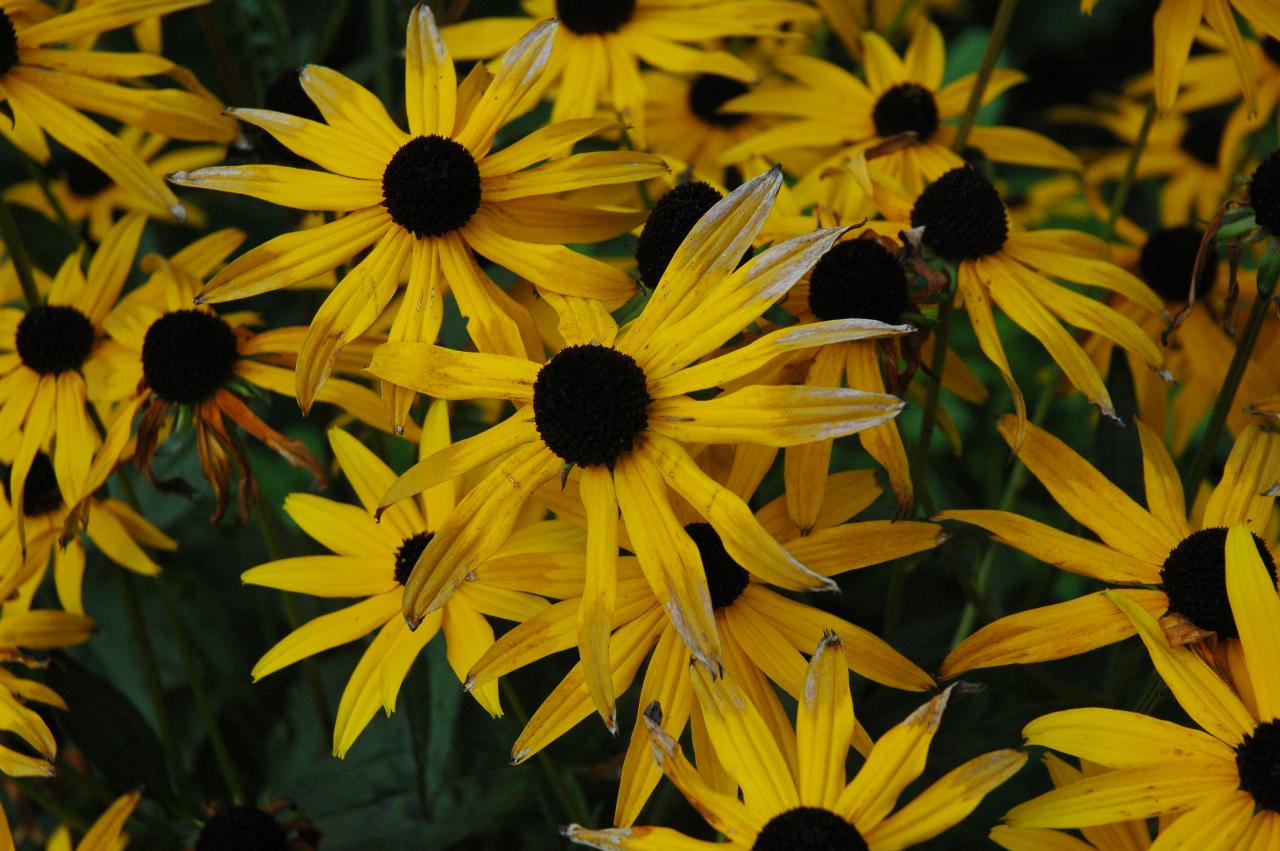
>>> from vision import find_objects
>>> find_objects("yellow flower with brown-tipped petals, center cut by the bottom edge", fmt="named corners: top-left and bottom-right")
top-left (564, 635), bottom-right (1027, 851)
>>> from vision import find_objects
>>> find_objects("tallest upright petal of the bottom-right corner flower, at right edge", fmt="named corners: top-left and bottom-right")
top-left (1226, 523), bottom-right (1280, 720)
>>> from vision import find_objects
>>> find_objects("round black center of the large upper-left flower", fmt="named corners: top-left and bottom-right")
top-left (383, 133), bottom-right (480, 239)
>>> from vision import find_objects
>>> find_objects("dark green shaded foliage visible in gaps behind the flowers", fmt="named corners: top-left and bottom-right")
top-left (0, 0), bottom-right (1228, 851)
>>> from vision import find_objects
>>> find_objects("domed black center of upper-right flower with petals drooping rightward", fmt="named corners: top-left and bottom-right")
top-left (911, 165), bottom-right (1009, 262)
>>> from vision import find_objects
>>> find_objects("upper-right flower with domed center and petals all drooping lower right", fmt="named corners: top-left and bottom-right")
top-left (896, 166), bottom-right (1165, 435)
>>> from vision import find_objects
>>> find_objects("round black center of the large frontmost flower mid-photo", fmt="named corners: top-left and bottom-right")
top-left (534, 346), bottom-right (650, 468)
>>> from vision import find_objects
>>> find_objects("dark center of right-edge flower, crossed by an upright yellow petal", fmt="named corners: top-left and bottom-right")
top-left (1160, 526), bottom-right (1276, 639)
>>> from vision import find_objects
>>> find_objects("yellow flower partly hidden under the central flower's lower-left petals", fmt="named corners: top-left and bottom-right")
top-left (241, 412), bottom-right (568, 756)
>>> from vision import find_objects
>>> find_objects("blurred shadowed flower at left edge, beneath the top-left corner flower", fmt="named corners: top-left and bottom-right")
top-left (4, 127), bottom-right (227, 242)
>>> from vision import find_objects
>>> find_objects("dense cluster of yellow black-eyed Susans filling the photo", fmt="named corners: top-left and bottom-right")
top-left (0, 0), bottom-right (1280, 851)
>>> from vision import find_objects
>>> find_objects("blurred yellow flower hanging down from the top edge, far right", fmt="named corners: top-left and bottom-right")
top-left (1080, 0), bottom-right (1280, 113)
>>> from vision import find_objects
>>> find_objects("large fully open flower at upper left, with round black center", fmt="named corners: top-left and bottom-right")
top-left (170, 4), bottom-right (666, 425)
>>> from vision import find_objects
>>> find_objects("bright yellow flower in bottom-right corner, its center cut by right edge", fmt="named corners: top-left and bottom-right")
top-left (1005, 523), bottom-right (1280, 851)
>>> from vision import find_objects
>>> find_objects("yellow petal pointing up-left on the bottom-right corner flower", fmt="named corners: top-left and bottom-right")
top-left (1102, 591), bottom-right (1254, 742)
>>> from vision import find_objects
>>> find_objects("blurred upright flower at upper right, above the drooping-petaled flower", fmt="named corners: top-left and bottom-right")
top-left (722, 20), bottom-right (1080, 203)
